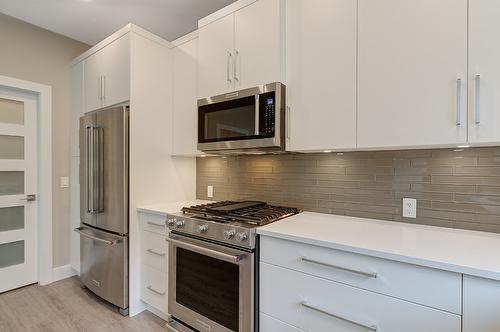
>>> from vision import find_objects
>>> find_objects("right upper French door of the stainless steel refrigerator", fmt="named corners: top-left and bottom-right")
top-left (94, 106), bottom-right (128, 234)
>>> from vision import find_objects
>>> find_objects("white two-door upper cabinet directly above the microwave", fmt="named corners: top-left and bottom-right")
top-left (198, 0), bottom-right (283, 98)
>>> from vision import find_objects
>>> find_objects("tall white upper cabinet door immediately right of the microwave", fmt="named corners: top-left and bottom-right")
top-left (286, 0), bottom-right (356, 151)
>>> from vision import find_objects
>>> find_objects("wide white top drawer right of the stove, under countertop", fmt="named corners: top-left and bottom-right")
top-left (260, 236), bottom-right (462, 314)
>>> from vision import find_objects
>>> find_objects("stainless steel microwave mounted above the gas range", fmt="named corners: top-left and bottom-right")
top-left (198, 82), bottom-right (285, 153)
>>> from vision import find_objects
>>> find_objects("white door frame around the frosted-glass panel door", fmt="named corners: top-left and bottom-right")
top-left (0, 75), bottom-right (53, 285)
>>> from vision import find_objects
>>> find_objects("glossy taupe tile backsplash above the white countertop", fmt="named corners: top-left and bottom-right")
top-left (197, 147), bottom-right (500, 233)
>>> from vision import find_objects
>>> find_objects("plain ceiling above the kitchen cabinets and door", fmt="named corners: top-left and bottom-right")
top-left (0, 0), bottom-right (235, 45)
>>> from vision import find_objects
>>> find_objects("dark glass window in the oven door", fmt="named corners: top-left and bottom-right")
top-left (176, 247), bottom-right (240, 331)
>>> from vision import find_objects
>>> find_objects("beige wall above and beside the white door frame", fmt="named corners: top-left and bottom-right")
top-left (0, 14), bottom-right (89, 267)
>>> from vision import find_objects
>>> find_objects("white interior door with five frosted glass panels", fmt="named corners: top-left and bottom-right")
top-left (0, 88), bottom-right (37, 292)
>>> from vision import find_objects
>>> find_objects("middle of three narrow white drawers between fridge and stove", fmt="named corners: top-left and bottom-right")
top-left (141, 231), bottom-right (168, 273)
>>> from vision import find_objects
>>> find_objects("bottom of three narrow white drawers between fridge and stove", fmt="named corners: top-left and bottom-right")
top-left (141, 265), bottom-right (168, 315)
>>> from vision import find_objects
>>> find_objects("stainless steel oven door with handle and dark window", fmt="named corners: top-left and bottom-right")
top-left (167, 233), bottom-right (254, 332)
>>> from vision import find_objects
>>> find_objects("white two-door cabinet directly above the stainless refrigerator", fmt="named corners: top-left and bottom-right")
top-left (84, 34), bottom-right (130, 112)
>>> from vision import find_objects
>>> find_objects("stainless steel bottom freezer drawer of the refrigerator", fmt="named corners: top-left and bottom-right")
top-left (75, 225), bottom-right (128, 309)
